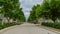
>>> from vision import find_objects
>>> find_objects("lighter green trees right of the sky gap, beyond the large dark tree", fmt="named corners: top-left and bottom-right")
top-left (28, 5), bottom-right (41, 22)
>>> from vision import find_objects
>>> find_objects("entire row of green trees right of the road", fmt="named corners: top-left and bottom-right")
top-left (28, 0), bottom-right (60, 23)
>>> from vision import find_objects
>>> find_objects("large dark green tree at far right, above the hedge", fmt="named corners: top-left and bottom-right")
top-left (42, 0), bottom-right (60, 22)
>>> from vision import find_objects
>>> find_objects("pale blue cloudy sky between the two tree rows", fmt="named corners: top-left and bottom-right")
top-left (20, 0), bottom-right (43, 19)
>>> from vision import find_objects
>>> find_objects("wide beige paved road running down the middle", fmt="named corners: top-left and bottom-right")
top-left (2, 23), bottom-right (56, 34)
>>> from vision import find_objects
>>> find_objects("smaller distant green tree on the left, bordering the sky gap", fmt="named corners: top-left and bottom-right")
top-left (13, 8), bottom-right (25, 22)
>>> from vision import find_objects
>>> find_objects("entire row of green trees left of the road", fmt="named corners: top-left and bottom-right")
top-left (0, 0), bottom-right (25, 22)
